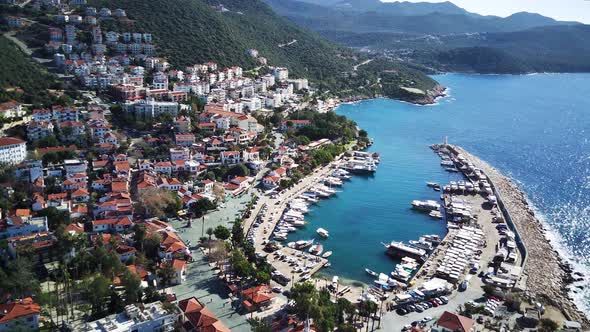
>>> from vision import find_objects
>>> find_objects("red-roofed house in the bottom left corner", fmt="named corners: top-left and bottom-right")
top-left (0, 297), bottom-right (41, 331)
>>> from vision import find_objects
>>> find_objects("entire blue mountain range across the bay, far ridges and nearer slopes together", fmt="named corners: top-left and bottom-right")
top-left (265, 0), bottom-right (590, 73)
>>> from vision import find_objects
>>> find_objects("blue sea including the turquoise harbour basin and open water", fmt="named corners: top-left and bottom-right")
top-left (289, 74), bottom-right (590, 312)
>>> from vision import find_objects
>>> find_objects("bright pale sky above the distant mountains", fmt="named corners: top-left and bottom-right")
top-left (382, 0), bottom-right (590, 24)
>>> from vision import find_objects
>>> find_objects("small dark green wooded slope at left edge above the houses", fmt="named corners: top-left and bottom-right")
top-left (0, 36), bottom-right (55, 104)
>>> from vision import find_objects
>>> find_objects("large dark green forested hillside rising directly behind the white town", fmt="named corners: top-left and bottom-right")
top-left (89, 0), bottom-right (444, 101)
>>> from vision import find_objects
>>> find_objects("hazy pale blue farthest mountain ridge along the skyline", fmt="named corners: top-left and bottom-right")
top-left (266, 0), bottom-right (577, 34)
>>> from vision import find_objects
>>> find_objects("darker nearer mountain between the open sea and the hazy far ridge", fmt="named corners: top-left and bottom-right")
top-left (324, 25), bottom-right (590, 73)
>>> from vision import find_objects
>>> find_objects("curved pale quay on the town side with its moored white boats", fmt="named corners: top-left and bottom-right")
top-left (246, 151), bottom-right (379, 302)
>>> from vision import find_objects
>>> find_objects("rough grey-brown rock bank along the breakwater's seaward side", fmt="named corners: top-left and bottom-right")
top-left (449, 146), bottom-right (590, 327)
